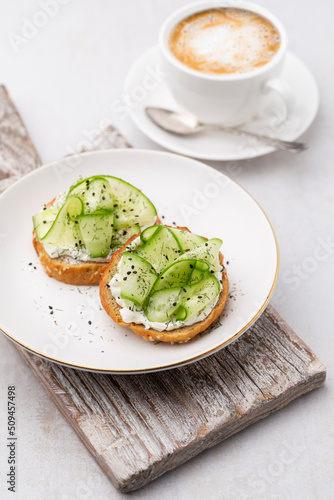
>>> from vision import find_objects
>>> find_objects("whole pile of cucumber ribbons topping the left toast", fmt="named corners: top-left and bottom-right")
top-left (33, 175), bottom-right (157, 258)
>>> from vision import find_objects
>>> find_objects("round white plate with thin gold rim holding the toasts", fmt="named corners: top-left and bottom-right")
top-left (0, 149), bottom-right (278, 373)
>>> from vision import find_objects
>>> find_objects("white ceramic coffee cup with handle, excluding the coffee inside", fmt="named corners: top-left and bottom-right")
top-left (159, 0), bottom-right (294, 126)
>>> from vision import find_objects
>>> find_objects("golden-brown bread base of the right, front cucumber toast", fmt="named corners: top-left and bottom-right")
top-left (100, 226), bottom-right (228, 343)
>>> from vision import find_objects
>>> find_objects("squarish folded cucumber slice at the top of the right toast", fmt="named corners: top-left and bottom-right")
top-left (136, 226), bottom-right (181, 273)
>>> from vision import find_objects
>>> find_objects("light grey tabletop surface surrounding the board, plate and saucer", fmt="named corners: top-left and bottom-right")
top-left (0, 0), bottom-right (334, 500)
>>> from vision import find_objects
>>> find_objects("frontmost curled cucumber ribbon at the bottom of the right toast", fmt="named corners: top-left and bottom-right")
top-left (144, 271), bottom-right (220, 322)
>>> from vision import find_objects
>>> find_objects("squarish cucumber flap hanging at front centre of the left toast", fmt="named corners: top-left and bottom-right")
top-left (77, 210), bottom-right (114, 258)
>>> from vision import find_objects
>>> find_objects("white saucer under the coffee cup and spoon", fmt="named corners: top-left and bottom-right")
top-left (124, 46), bottom-right (319, 160)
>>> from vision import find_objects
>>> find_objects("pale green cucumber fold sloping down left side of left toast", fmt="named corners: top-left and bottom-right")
top-left (41, 196), bottom-right (83, 248)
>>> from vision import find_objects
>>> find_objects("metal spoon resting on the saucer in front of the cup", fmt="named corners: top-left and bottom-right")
top-left (145, 106), bottom-right (307, 153)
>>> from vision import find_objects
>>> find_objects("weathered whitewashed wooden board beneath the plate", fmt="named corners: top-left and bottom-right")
top-left (0, 88), bottom-right (326, 492)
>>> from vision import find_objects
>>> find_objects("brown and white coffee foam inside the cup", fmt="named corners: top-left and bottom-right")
top-left (169, 8), bottom-right (281, 74)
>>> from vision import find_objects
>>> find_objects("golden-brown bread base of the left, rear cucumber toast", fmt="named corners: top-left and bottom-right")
top-left (32, 198), bottom-right (161, 286)
